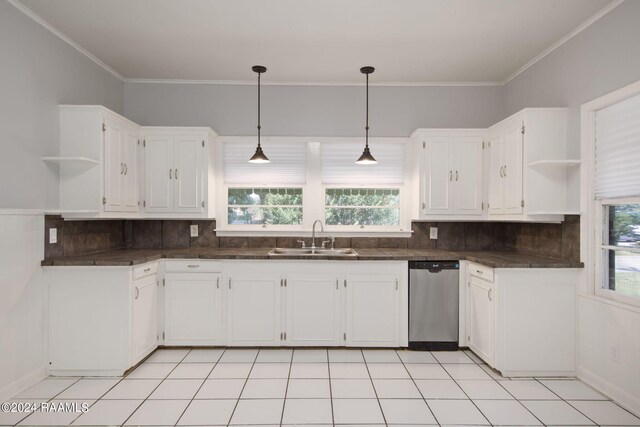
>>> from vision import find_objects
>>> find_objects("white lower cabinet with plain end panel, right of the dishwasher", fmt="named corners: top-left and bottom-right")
top-left (464, 261), bottom-right (580, 377)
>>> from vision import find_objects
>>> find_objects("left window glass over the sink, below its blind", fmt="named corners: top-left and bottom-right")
top-left (227, 188), bottom-right (302, 225)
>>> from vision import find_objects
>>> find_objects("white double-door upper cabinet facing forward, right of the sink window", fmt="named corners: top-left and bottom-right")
top-left (412, 129), bottom-right (484, 219)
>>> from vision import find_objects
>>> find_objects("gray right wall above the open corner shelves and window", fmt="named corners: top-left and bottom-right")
top-left (502, 0), bottom-right (640, 157)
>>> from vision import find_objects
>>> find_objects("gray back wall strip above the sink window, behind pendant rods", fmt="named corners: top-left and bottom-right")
top-left (124, 83), bottom-right (502, 136)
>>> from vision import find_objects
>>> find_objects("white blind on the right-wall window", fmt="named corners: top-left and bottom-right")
top-left (595, 95), bottom-right (640, 198)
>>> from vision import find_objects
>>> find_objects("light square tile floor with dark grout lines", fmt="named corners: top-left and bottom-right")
top-left (0, 349), bottom-right (640, 427)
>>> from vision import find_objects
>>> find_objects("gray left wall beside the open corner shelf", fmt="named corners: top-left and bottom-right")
top-left (0, 1), bottom-right (123, 209)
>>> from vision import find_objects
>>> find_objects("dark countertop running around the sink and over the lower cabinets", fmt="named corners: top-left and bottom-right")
top-left (42, 248), bottom-right (583, 268)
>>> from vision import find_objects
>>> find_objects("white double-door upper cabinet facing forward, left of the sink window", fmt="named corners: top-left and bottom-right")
top-left (142, 127), bottom-right (217, 218)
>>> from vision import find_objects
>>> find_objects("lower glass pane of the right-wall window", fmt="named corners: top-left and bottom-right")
top-left (605, 250), bottom-right (640, 297)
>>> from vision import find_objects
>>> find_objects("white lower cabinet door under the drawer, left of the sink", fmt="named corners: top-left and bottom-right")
top-left (164, 273), bottom-right (222, 345)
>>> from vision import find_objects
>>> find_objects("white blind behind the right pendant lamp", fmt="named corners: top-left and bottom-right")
top-left (321, 142), bottom-right (405, 185)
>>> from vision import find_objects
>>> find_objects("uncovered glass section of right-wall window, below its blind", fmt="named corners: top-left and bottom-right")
top-left (601, 199), bottom-right (640, 298)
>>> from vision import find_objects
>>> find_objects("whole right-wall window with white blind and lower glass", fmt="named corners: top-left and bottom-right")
top-left (591, 89), bottom-right (640, 305)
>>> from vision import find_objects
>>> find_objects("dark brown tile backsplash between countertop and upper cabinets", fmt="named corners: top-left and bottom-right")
top-left (45, 215), bottom-right (580, 261)
